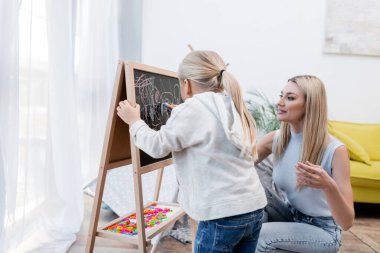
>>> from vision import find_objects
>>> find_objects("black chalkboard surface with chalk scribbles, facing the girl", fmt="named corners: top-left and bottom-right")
top-left (129, 64), bottom-right (181, 166)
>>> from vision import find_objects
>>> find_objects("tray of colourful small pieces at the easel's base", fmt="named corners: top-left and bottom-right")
top-left (98, 202), bottom-right (185, 240)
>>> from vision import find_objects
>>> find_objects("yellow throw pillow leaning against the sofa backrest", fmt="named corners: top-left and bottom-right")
top-left (329, 128), bottom-right (371, 164)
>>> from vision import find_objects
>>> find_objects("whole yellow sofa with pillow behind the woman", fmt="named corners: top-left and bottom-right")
top-left (328, 121), bottom-right (380, 204)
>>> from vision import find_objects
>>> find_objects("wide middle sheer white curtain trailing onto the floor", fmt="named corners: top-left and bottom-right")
top-left (8, 0), bottom-right (83, 253)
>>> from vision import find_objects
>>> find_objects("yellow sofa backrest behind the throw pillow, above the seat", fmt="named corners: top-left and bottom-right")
top-left (329, 121), bottom-right (380, 161)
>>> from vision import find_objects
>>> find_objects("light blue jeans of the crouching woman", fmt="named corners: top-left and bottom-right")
top-left (256, 189), bottom-right (341, 253)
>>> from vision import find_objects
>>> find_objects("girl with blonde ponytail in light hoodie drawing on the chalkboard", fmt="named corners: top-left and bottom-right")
top-left (117, 51), bottom-right (266, 252)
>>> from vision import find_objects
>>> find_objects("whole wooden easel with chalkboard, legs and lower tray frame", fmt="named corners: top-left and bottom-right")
top-left (86, 61), bottom-right (185, 253)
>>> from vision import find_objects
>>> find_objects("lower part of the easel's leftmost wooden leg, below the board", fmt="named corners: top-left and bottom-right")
top-left (85, 167), bottom-right (107, 253)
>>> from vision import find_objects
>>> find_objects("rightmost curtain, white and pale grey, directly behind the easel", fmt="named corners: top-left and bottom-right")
top-left (76, 0), bottom-right (142, 185)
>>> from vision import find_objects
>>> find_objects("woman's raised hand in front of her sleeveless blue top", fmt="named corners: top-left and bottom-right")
top-left (296, 162), bottom-right (333, 190)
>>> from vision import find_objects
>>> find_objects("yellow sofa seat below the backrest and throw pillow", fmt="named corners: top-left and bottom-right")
top-left (350, 161), bottom-right (380, 189)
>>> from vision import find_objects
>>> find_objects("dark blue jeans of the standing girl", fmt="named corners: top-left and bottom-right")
top-left (194, 209), bottom-right (263, 253)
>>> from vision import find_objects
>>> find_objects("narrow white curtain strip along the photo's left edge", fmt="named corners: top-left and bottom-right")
top-left (0, 0), bottom-right (19, 252)
